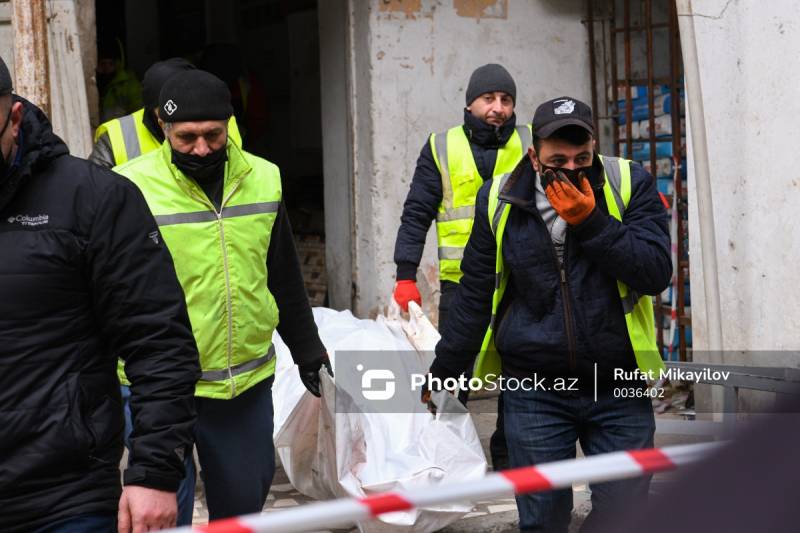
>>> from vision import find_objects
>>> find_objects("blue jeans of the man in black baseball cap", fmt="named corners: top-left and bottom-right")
top-left (505, 390), bottom-right (655, 533)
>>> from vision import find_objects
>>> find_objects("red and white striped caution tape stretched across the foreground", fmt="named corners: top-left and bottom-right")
top-left (171, 443), bottom-right (719, 533)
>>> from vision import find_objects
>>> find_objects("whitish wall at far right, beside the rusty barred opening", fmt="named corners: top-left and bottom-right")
top-left (682, 0), bottom-right (800, 367)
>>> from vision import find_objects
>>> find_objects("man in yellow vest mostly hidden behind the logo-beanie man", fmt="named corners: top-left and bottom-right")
top-left (89, 57), bottom-right (242, 168)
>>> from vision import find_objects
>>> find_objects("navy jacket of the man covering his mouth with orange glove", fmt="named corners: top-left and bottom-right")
top-left (432, 156), bottom-right (672, 393)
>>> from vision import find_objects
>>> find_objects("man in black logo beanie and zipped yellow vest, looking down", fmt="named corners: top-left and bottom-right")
top-left (115, 70), bottom-right (332, 520)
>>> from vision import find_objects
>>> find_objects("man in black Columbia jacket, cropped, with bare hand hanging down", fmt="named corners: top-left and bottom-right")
top-left (0, 59), bottom-right (200, 533)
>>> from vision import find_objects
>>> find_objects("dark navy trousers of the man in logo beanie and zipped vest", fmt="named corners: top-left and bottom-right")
top-left (122, 377), bottom-right (275, 525)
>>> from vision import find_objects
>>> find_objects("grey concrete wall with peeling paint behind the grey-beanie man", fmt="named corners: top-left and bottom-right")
top-left (340, 0), bottom-right (590, 316)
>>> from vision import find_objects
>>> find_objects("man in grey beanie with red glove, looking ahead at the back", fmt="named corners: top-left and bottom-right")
top-left (394, 63), bottom-right (531, 469)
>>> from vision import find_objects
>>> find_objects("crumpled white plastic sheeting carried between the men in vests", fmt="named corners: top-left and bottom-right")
top-left (273, 306), bottom-right (486, 532)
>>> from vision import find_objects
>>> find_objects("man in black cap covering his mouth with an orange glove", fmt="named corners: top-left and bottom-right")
top-left (431, 97), bottom-right (672, 532)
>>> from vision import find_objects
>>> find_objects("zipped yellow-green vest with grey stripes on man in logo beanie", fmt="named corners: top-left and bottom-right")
top-left (114, 141), bottom-right (281, 399)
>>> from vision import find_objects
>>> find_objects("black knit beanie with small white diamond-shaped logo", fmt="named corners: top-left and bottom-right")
top-left (158, 70), bottom-right (233, 122)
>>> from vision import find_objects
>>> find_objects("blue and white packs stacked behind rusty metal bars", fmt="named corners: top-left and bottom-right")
top-left (617, 81), bottom-right (692, 360)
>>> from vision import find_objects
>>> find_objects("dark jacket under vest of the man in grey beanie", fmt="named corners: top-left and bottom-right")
top-left (394, 110), bottom-right (516, 280)
